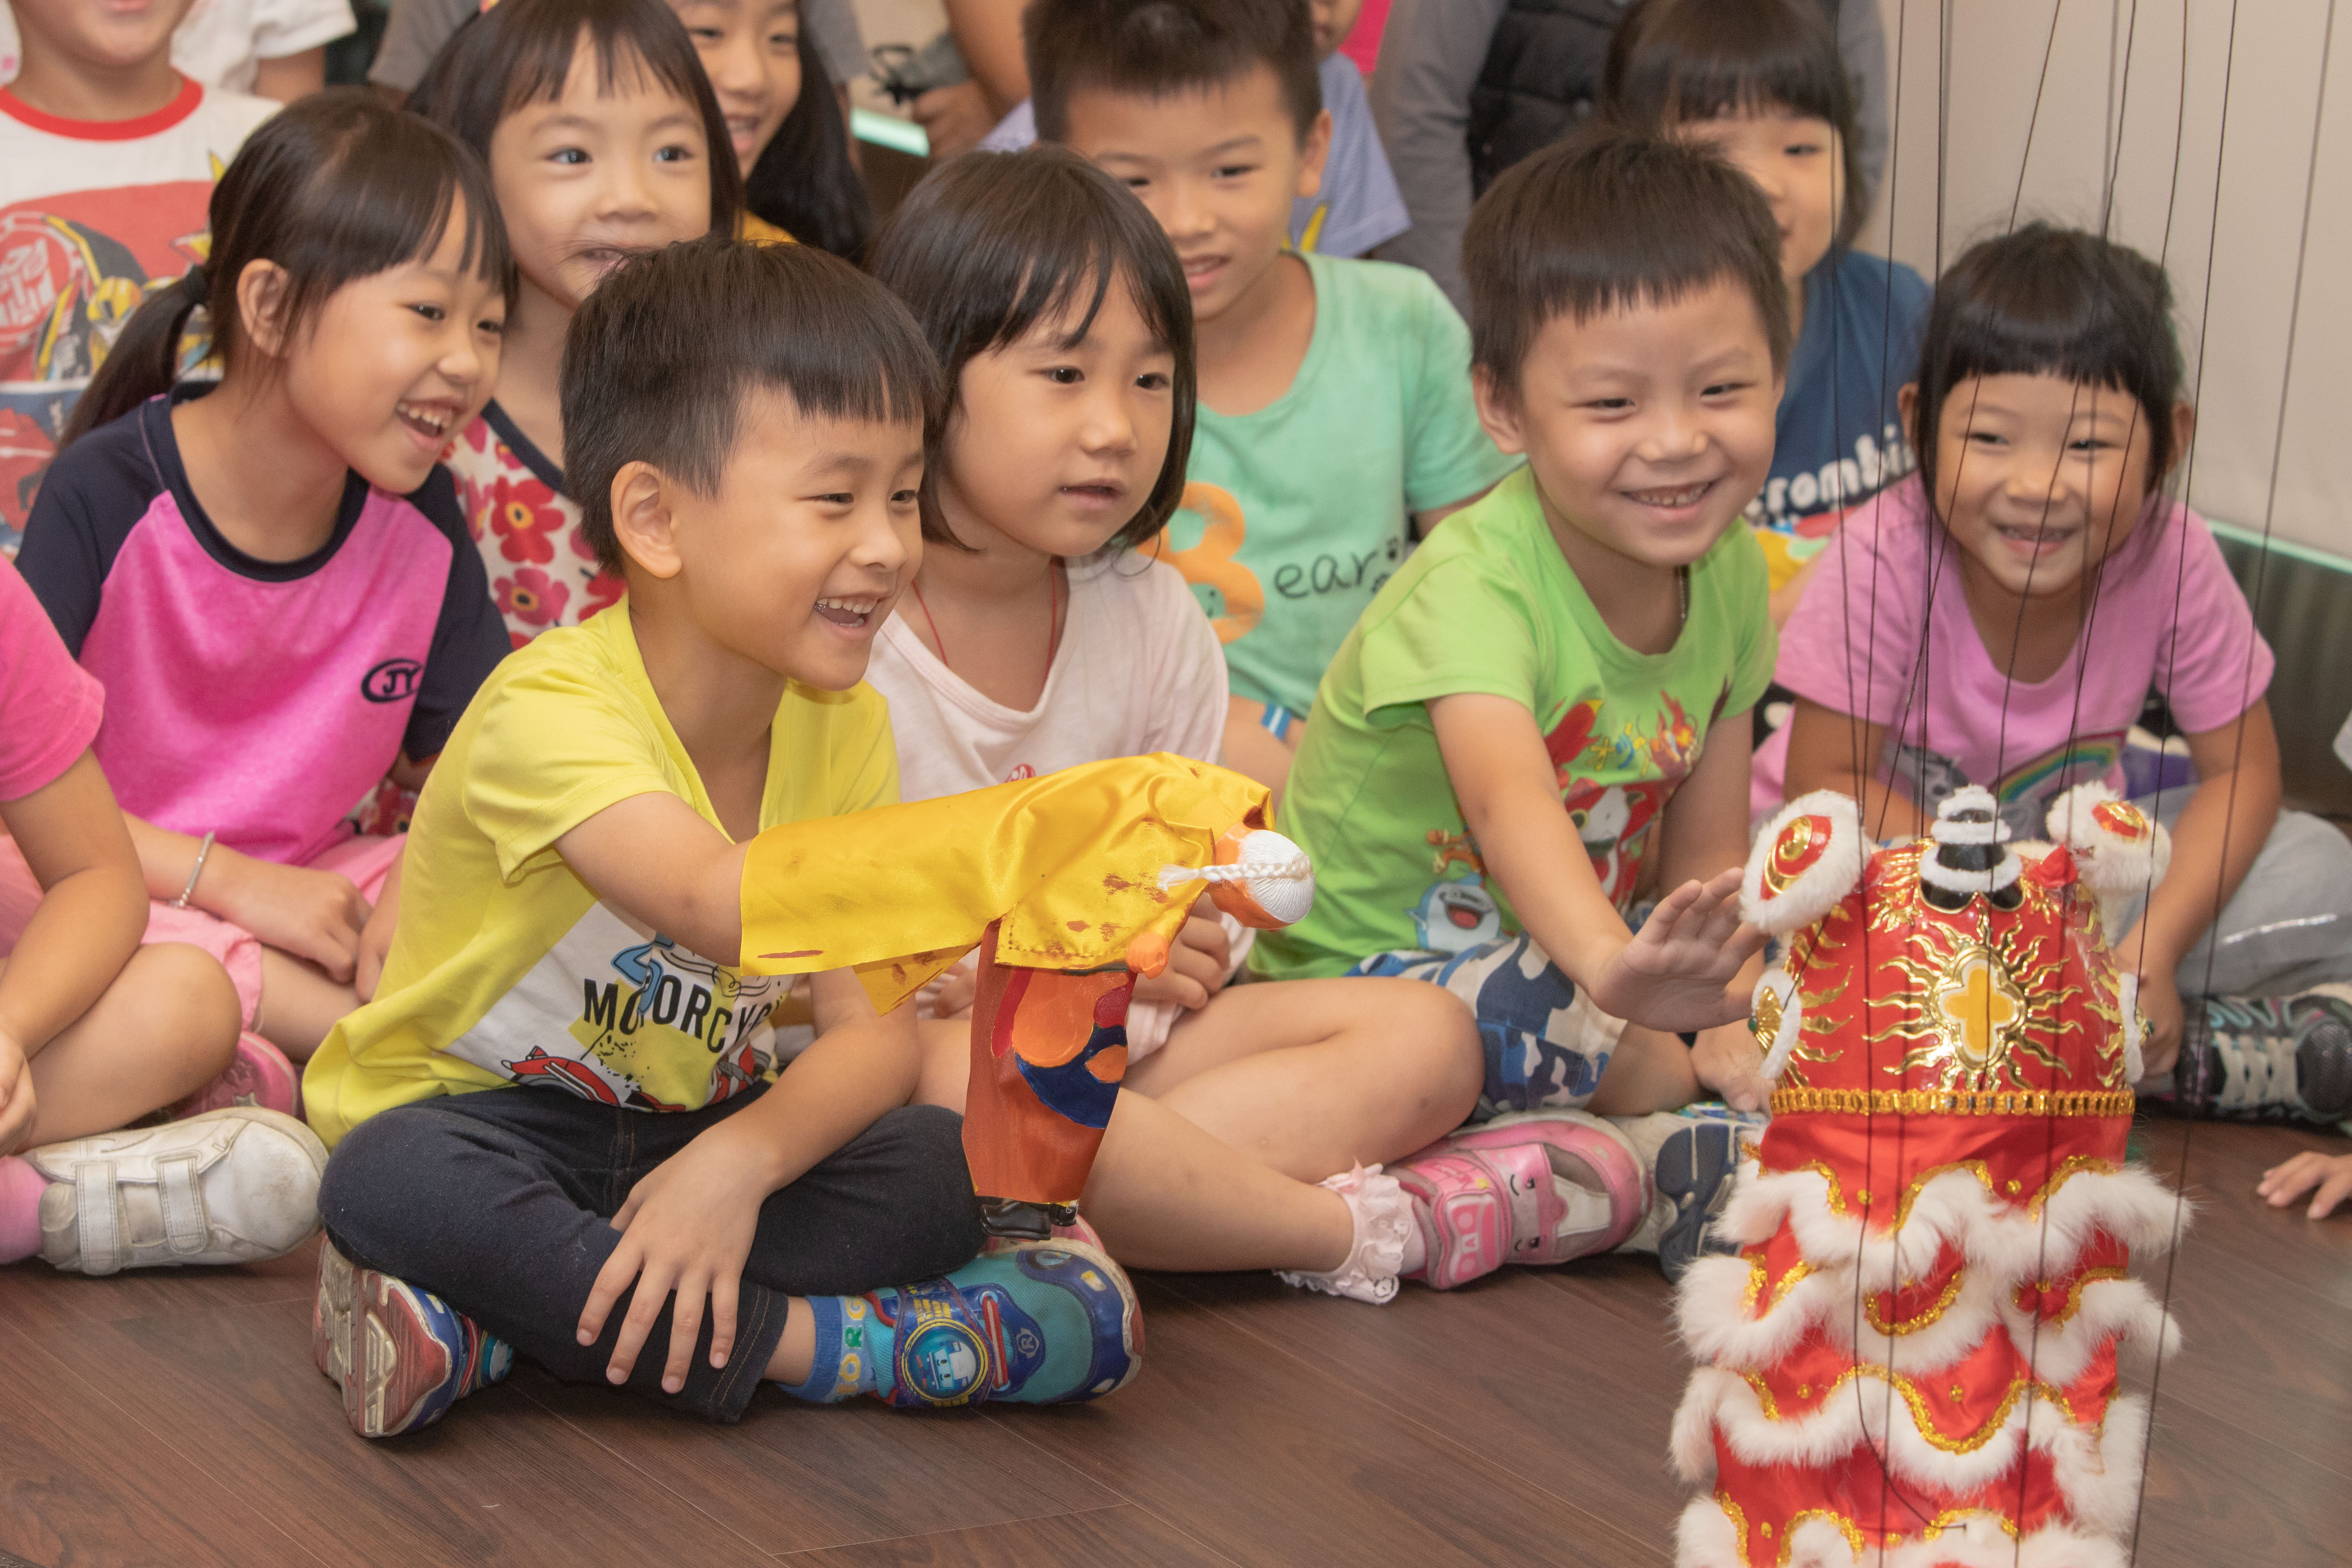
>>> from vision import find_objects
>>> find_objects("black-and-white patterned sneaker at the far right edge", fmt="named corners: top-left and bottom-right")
top-left (2171, 985), bottom-right (2352, 1124)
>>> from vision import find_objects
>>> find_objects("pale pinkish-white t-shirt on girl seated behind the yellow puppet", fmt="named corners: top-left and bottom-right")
top-left (866, 553), bottom-right (1251, 1060)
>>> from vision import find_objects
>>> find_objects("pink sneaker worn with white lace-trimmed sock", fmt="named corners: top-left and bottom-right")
top-left (1392, 1110), bottom-right (1649, 1291)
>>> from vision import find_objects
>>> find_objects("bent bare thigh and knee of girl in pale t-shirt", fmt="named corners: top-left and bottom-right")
top-left (1126, 978), bottom-right (1486, 1183)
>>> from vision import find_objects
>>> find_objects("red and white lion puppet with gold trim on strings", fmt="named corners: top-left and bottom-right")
top-left (1672, 785), bottom-right (2180, 1568)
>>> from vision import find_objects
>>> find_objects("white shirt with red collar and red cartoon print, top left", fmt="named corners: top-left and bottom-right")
top-left (0, 82), bottom-right (277, 550)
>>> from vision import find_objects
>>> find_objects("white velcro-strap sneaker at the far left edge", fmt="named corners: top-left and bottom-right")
top-left (24, 1105), bottom-right (327, 1274)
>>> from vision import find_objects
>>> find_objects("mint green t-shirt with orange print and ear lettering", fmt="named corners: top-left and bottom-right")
top-left (1160, 254), bottom-right (1517, 712)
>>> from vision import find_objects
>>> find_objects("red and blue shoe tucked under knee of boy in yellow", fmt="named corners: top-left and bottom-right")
top-left (310, 1241), bottom-right (515, 1436)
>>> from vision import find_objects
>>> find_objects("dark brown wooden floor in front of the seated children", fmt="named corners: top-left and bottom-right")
top-left (0, 1122), bottom-right (2352, 1568)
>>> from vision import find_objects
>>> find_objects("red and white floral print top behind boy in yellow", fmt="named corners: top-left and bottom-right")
top-left (442, 402), bottom-right (621, 649)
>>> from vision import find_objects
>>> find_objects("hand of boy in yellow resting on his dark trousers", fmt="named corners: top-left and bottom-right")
top-left (579, 1122), bottom-right (771, 1394)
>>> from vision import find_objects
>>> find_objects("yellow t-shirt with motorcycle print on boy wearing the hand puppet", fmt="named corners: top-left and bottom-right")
top-left (303, 602), bottom-right (899, 1145)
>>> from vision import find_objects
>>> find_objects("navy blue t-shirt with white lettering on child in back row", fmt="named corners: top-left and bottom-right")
top-left (1747, 251), bottom-right (1929, 588)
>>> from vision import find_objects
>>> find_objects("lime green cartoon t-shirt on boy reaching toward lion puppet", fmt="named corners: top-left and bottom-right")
top-left (1251, 470), bottom-right (1776, 980)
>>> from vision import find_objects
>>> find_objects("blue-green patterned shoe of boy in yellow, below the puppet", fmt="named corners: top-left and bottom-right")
top-left (866, 1236), bottom-right (1143, 1408)
